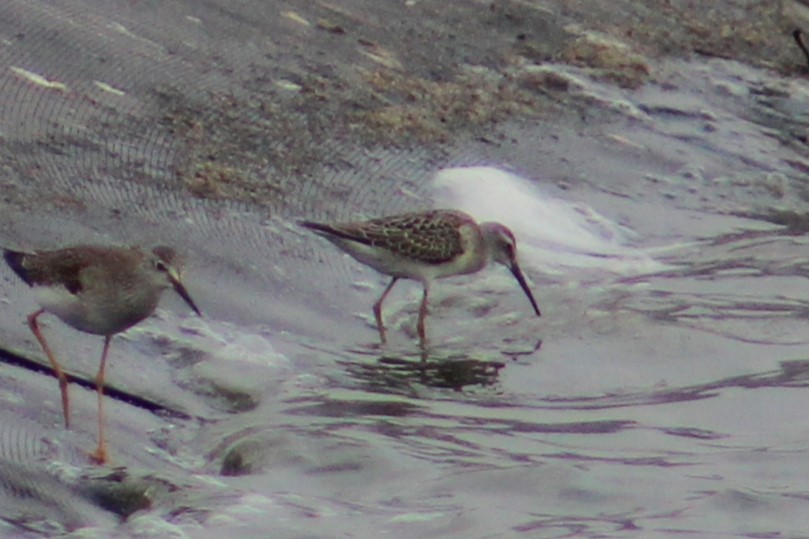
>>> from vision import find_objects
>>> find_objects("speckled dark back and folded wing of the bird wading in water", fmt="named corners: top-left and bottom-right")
top-left (301, 210), bottom-right (475, 264)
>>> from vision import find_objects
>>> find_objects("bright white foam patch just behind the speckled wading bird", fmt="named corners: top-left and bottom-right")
top-left (433, 167), bottom-right (666, 274)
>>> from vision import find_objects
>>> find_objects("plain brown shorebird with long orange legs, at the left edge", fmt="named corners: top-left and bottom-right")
top-left (3, 245), bottom-right (201, 464)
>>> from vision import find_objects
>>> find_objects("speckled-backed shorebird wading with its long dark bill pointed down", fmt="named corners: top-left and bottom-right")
top-left (300, 210), bottom-right (540, 347)
